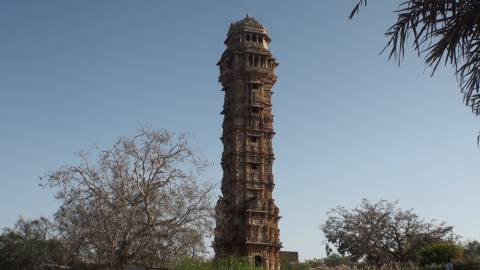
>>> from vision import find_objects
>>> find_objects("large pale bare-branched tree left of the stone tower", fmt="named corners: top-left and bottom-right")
top-left (43, 128), bottom-right (213, 269)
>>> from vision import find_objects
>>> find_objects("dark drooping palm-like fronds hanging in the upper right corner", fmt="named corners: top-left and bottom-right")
top-left (350, 0), bottom-right (480, 137)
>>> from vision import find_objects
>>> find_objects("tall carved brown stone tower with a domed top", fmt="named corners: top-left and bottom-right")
top-left (213, 15), bottom-right (281, 270)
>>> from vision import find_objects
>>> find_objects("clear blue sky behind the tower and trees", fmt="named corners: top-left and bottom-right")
top-left (0, 0), bottom-right (480, 258)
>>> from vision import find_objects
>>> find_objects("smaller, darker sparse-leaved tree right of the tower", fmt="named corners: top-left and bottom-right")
top-left (321, 199), bottom-right (456, 267)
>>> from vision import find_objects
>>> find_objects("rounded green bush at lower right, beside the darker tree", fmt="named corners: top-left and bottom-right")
top-left (420, 242), bottom-right (463, 265)
